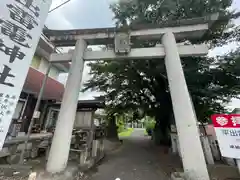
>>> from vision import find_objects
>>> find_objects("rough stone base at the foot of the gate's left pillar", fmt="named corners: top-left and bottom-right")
top-left (36, 166), bottom-right (79, 180)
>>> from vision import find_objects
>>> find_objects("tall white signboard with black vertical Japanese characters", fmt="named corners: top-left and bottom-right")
top-left (0, 0), bottom-right (52, 150)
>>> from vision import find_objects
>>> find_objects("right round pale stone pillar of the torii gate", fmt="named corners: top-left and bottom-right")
top-left (162, 32), bottom-right (209, 180)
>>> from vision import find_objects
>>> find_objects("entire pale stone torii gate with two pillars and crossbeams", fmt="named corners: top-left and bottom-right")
top-left (45, 14), bottom-right (218, 180)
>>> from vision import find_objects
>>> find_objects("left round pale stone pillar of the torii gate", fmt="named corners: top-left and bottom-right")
top-left (46, 39), bottom-right (87, 173)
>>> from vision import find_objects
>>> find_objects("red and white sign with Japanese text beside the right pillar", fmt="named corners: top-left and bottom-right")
top-left (211, 114), bottom-right (240, 159)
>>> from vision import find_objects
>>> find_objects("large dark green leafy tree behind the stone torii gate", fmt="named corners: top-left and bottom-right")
top-left (84, 0), bottom-right (240, 144)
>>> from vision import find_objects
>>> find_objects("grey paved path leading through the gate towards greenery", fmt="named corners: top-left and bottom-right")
top-left (88, 129), bottom-right (168, 180)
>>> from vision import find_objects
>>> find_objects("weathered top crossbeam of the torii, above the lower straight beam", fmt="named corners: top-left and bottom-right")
top-left (44, 14), bottom-right (218, 46)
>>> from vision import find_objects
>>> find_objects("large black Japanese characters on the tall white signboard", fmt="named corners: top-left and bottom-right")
top-left (0, 0), bottom-right (40, 87)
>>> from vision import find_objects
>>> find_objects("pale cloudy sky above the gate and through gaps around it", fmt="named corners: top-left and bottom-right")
top-left (46, 0), bottom-right (240, 110)
